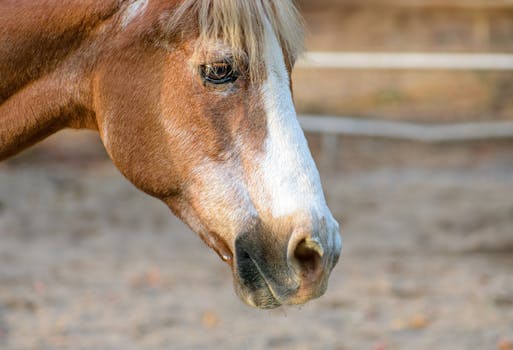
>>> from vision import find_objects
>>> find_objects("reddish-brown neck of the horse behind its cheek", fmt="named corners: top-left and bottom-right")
top-left (0, 0), bottom-right (122, 161)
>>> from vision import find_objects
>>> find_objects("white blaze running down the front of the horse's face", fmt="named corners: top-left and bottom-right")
top-left (259, 23), bottom-right (341, 252)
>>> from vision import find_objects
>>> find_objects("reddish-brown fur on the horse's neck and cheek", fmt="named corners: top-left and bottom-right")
top-left (0, 0), bottom-right (272, 266)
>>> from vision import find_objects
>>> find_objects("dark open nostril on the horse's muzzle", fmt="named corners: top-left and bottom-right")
top-left (294, 239), bottom-right (323, 279)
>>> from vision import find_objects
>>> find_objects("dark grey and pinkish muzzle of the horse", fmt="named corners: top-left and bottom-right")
top-left (233, 223), bottom-right (341, 309)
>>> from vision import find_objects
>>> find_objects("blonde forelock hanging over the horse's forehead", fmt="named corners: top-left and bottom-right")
top-left (170, 0), bottom-right (304, 79)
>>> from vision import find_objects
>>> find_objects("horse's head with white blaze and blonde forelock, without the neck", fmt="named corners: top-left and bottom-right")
top-left (94, 0), bottom-right (341, 308)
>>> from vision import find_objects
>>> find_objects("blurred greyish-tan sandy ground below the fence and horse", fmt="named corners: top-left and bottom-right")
top-left (0, 133), bottom-right (513, 350)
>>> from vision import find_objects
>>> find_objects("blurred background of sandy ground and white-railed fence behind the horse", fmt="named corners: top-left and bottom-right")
top-left (0, 0), bottom-right (513, 350)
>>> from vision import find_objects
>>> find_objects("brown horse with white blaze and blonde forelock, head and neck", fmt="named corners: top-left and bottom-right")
top-left (0, 0), bottom-right (341, 308)
